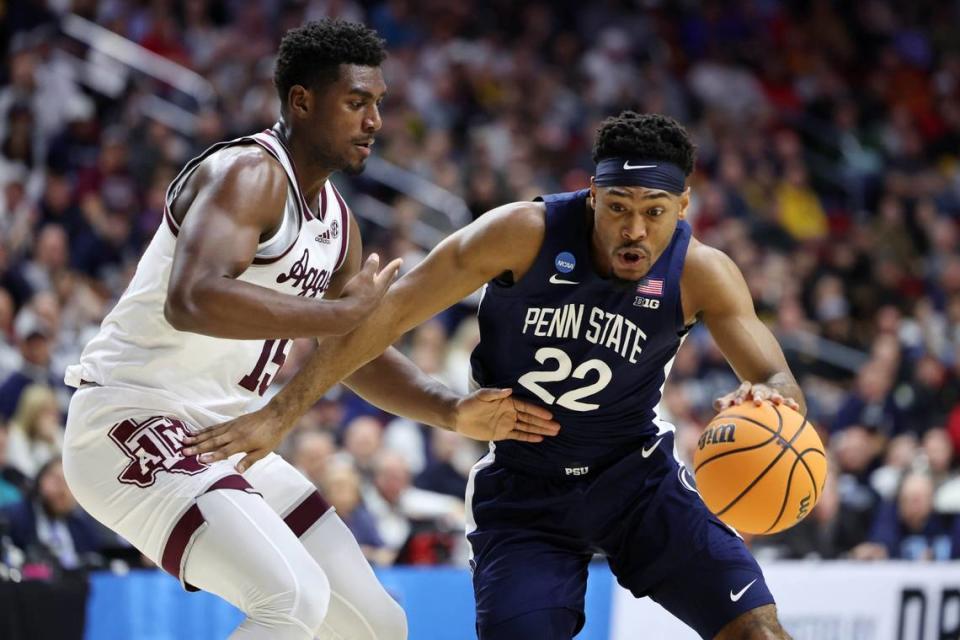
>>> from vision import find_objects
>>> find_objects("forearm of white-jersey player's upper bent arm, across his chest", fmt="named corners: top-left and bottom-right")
top-left (164, 278), bottom-right (360, 340)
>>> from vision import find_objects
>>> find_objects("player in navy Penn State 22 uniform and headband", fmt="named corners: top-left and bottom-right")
top-left (188, 112), bottom-right (804, 640)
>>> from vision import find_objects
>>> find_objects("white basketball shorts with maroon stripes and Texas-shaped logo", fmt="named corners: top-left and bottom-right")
top-left (63, 385), bottom-right (332, 588)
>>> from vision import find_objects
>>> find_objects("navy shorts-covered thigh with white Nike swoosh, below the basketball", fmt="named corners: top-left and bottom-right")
top-left (609, 467), bottom-right (774, 638)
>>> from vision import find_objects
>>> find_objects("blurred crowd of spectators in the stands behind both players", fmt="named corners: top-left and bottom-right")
top-left (0, 0), bottom-right (960, 580)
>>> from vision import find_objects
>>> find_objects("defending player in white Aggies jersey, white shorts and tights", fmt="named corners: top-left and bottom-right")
top-left (63, 21), bottom-right (558, 640)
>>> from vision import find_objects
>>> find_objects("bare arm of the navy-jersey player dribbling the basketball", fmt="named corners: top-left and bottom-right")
top-left (682, 241), bottom-right (806, 412)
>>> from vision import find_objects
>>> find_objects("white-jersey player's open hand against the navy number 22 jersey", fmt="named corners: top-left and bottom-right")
top-left (455, 389), bottom-right (560, 442)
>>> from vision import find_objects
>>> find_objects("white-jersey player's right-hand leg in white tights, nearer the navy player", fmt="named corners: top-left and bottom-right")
top-left (244, 454), bottom-right (407, 640)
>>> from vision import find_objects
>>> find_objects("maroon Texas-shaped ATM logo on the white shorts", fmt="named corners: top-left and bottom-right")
top-left (110, 416), bottom-right (209, 487)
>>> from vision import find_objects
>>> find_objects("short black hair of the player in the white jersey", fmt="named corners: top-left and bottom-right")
top-left (273, 19), bottom-right (387, 107)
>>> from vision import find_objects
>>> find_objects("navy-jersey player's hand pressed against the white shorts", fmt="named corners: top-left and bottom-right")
top-left (183, 405), bottom-right (289, 473)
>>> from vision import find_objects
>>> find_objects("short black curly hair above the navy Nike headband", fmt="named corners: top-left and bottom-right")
top-left (593, 111), bottom-right (696, 175)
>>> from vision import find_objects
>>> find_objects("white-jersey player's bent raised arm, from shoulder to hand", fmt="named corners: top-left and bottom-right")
top-left (164, 147), bottom-right (399, 340)
